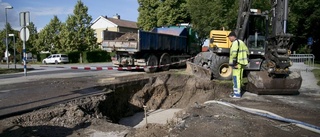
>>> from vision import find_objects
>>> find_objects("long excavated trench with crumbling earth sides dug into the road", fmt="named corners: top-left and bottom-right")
top-left (1, 74), bottom-right (231, 128)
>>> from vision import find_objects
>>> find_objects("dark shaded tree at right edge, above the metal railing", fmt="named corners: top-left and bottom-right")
top-left (288, 0), bottom-right (320, 57)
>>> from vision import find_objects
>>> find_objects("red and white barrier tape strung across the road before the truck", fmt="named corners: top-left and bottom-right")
top-left (40, 57), bottom-right (195, 70)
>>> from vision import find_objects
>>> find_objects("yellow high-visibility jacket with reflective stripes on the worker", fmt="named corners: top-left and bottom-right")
top-left (229, 39), bottom-right (249, 65)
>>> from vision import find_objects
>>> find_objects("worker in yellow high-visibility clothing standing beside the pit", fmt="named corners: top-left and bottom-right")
top-left (228, 31), bottom-right (249, 98)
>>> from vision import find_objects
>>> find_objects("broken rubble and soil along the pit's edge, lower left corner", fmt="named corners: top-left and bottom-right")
top-left (0, 95), bottom-right (126, 137)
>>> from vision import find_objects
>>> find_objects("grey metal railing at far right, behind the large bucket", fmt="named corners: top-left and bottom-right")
top-left (289, 54), bottom-right (315, 67)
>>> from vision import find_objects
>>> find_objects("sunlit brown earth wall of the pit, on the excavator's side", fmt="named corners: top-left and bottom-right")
top-left (130, 74), bottom-right (231, 110)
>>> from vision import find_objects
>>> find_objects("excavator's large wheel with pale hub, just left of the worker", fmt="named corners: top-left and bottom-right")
top-left (210, 55), bottom-right (232, 80)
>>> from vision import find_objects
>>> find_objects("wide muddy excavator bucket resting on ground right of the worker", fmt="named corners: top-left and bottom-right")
top-left (246, 71), bottom-right (302, 95)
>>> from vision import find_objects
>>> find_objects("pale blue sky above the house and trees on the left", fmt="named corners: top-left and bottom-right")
top-left (0, 0), bottom-right (139, 32)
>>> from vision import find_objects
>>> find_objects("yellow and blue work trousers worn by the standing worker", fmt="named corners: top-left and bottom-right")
top-left (232, 64), bottom-right (245, 97)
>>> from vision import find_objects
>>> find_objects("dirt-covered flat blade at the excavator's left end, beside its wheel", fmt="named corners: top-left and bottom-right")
top-left (186, 61), bottom-right (212, 80)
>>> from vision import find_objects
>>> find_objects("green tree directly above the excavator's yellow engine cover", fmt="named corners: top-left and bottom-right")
top-left (187, 0), bottom-right (238, 38)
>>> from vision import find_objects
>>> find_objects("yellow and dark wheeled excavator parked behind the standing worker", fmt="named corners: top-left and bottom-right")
top-left (187, 0), bottom-right (302, 95)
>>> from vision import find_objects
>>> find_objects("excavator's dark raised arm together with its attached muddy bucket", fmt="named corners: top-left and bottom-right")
top-left (242, 0), bottom-right (302, 94)
